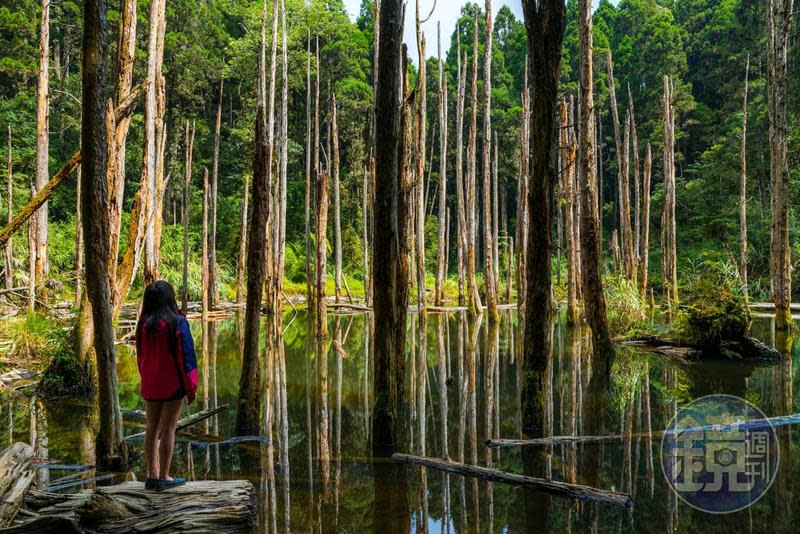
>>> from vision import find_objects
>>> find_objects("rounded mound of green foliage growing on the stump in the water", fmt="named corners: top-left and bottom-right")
top-left (672, 257), bottom-right (751, 347)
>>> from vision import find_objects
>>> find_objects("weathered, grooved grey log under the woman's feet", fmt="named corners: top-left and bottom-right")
top-left (4, 480), bottom-right (256, 534)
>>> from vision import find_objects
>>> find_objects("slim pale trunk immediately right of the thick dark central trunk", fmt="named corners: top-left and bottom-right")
top-left (414, 6), bottom-right (428, 321)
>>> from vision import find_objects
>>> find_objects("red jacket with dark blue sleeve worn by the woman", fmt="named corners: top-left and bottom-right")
top-left (136, 315), bottom-right (197, 401)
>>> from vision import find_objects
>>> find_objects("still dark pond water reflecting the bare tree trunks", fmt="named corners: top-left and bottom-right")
top-left (0, 311), bottom-right (800, 532)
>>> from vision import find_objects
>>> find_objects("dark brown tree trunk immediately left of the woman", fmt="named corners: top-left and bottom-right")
top-left (81, 0), bottom-right (127, 469)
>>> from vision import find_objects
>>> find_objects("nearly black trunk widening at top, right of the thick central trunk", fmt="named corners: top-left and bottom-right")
top-left (522, 0), bottom-right (564, 435)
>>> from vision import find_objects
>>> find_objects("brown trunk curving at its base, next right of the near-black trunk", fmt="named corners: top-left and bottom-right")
top-left (578, 0), bottom-right (616, 357)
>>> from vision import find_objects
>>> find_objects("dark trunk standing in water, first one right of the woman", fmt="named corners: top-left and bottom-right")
top-left (236, 0), bottom-right (270, 435)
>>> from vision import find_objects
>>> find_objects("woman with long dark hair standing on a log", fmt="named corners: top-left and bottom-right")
top-left (136, 280), bottom-right (197, 491)
